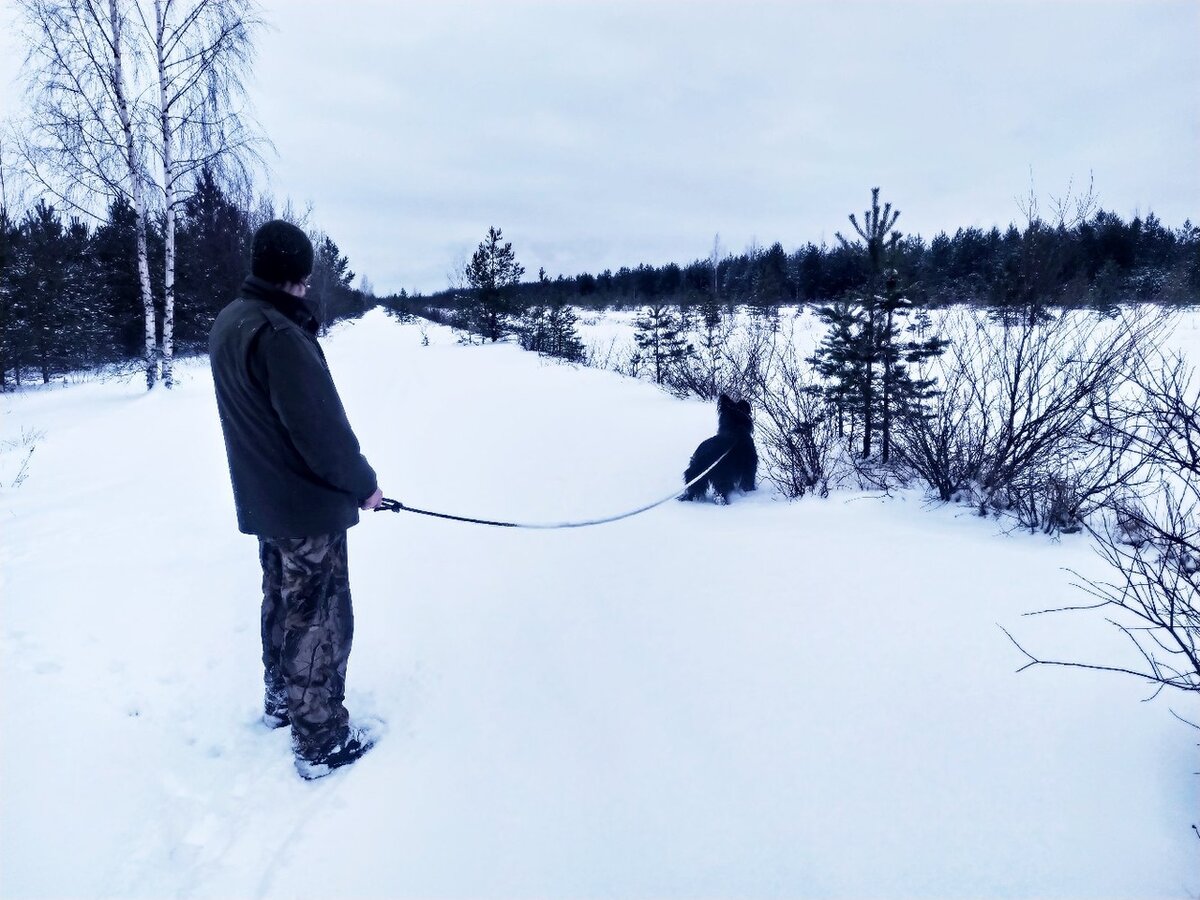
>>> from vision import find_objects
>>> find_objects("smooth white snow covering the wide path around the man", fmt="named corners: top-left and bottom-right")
top-left (0, 311), bottom-right (1200, 898)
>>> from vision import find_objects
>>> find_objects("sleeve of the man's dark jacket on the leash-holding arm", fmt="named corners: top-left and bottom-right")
top-left (259, 329), bottom-right (378, 503)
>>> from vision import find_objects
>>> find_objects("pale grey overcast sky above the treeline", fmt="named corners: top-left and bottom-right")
top-left (0, 0), bottom-right (1200, 293)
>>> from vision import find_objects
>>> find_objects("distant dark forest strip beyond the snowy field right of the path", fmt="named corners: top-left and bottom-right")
top-left (398, 210), bottom-right (1200, 318)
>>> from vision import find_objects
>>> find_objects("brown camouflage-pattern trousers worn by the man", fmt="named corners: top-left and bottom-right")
top-left (258, 532), bottom-right (354, 758)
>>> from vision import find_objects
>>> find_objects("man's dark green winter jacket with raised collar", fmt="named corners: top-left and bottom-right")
top-left (209, 276), bottom-right (377, 538)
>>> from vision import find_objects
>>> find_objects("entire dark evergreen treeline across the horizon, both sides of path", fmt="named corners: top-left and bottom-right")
top-left (0, 170), bottom-right (1200, 390)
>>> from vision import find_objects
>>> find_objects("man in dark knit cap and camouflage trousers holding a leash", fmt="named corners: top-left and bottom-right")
top-left (209, 220), bottom-right (383, 779)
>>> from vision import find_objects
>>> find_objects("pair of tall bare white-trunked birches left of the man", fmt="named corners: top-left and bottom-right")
top-left (18, 0), bottom-right (260, 388)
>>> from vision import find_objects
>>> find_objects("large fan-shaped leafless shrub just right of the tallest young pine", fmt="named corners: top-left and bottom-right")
top-left (895, 311), bottom-right (1169, 533)
